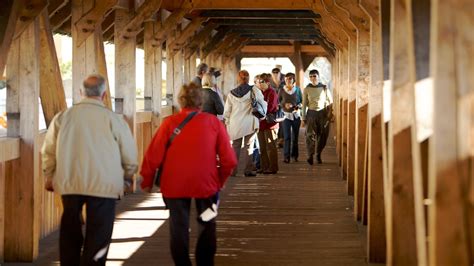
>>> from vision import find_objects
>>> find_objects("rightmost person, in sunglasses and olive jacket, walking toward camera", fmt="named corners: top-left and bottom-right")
top-left (301, 69), bottom-right (333, 165)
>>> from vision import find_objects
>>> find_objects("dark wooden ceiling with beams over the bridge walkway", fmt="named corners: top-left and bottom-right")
top-left (48, 0), bottom-right (335, 54)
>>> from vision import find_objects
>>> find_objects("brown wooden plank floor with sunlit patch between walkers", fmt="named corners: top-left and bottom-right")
top-left (25, 130), bottom-right (367, 266)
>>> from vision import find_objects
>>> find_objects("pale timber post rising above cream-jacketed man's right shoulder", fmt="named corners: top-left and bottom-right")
top-left (114, 5), bottom-right (136, 132)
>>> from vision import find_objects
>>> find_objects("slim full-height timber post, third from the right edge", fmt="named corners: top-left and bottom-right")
top-left (362, 0), bottom-right (386, 263)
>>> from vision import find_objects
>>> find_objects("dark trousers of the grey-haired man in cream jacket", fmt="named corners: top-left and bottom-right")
top-left (59, 195), bottom-right (116, 266)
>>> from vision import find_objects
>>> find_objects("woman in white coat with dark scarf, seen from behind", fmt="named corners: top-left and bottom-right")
top-left (224, 70), bottom-right (267, 176)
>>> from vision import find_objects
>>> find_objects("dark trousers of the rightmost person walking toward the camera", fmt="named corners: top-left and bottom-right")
top-left (306, 109), bottom-right (330, 157)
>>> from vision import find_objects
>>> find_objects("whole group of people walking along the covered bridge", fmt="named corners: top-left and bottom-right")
top-left (42, 63), bottom-right (332, 265)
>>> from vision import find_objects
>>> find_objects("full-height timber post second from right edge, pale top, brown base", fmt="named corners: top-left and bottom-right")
top-left (388, 0), bottom-right (427, 265)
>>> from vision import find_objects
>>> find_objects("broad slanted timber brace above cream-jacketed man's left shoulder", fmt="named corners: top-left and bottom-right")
top-left (39, 9), bottom-right (67, 126)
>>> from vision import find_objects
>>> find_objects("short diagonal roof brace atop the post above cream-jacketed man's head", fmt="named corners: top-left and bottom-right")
top-left (72, 0), bottom-right (118, 46)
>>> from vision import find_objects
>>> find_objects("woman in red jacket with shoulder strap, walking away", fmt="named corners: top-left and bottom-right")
top-left (140, 85), bottom-right (237, 265)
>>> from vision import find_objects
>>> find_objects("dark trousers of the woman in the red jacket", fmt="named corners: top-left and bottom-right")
top-left (165, 196), bottom-right (217, 266)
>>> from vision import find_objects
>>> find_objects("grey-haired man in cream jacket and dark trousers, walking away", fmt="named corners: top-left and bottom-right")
top-left (41, 75), bottom-right (138, 265)
